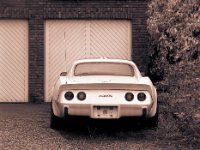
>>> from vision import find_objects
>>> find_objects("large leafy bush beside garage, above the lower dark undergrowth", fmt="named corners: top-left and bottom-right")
top-left (147, 0), bottom-right (200, 81)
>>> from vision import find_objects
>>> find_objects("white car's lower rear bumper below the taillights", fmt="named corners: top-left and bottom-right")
top-left (52, 102), bottom-right (153, 119)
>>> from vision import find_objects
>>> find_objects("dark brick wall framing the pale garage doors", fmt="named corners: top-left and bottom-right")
top-left (0, 0), bottom-right (148, 102)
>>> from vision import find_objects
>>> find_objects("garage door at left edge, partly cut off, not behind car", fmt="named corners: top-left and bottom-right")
top-left (0, 20), bottom-right (28, 102)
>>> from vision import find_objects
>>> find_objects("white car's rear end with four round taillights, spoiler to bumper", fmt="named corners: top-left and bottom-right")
top-left (55, 84), bottom-right (155, 119)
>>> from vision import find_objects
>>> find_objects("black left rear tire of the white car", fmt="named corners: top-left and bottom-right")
top-left (50, 108), bottom-right (63, 129)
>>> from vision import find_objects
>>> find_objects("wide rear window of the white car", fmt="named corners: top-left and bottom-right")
top-left (74, 62), bottom-right (134, 76)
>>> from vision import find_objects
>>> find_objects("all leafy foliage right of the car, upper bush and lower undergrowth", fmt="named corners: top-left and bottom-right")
top-left (147, 0), bottom-right (200, 145)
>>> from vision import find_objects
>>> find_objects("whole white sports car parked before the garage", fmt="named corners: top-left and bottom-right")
top-left (50, 59), bottom-right (158, 128)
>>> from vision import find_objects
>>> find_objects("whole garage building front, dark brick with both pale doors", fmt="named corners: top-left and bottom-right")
top-left (0, 0), bottom-right (148, 102)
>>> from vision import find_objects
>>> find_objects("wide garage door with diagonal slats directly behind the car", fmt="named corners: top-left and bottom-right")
top-left (45, 20), bottom-right (131, 101)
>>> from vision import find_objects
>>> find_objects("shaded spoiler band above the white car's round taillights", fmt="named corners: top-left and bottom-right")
top-left (59, 83), bottom-right (156, 99)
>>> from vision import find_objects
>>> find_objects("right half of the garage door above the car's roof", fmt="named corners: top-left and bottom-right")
top-left (91, 21), bottom-right (131, 59)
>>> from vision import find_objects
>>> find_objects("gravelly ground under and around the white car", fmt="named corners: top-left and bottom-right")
top-left (0, 102), bottom-right (200, 150)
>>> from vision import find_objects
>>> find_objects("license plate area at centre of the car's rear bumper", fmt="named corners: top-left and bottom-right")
top-left (93, 106), bottom-right (118, 119)
